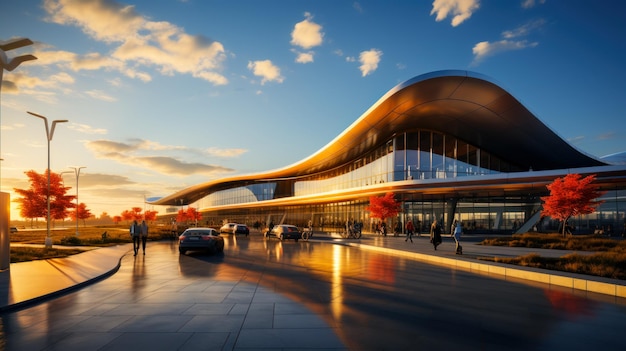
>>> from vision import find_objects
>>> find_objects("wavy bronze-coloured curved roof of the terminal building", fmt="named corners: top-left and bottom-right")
top-left (151, 71), bottom-right (606, 205)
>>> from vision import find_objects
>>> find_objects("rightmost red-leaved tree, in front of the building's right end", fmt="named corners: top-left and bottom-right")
top-left (541, 173), bottom-right (605, 236)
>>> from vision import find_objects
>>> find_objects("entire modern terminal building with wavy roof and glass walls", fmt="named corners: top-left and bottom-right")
top-left (152, 71), bottom-right (626, 233)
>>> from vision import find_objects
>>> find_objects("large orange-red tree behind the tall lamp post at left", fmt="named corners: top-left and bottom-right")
top-left (14, 170), bottom-right (76, 227)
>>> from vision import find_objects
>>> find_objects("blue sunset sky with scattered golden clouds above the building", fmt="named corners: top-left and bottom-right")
top-left (0, 0), bottom-right (626, 219)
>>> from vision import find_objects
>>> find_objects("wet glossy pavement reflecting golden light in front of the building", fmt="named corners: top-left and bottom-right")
top-left (1, 235), bottom-right (626, 350)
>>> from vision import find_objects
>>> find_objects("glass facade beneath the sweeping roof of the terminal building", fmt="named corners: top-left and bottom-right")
top-left (177, 130), bottom-right (626, 233)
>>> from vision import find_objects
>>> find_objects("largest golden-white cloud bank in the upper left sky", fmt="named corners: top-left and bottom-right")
top-left (42, 0), bottom-right (228, 85)
